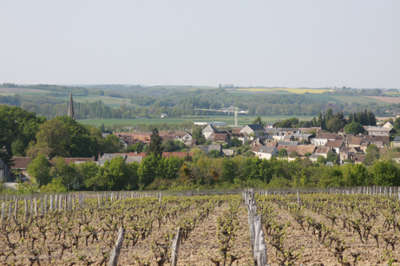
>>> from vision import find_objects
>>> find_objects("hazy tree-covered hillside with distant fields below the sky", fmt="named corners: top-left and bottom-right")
top-left (0, 84), bottom-right (400, 119)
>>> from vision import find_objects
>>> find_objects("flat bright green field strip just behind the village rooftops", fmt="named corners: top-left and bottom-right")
top-left (79, 116), bottom-right (312, 127)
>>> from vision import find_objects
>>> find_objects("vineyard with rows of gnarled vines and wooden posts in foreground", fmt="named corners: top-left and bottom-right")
top-left (0, 190), bottom-right (400, 266)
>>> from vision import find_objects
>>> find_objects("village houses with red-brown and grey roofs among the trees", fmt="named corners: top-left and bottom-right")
top-left (0, 118), bottom-right (400, 183)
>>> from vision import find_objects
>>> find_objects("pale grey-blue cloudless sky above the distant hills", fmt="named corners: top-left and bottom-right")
top-left (0, 0), bottom-right (400, 88)
